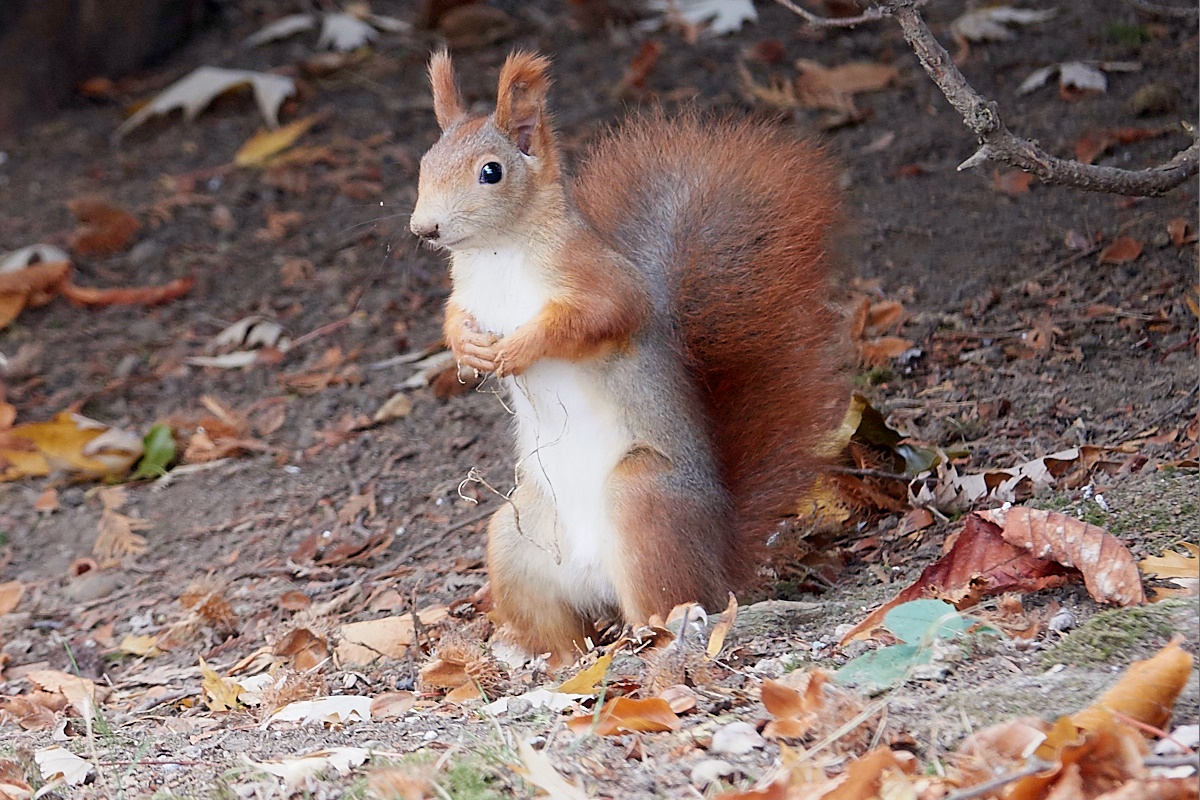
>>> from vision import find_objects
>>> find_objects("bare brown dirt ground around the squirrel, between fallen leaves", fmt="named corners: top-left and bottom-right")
top-left (0, 0), bottom-right (1200, 798)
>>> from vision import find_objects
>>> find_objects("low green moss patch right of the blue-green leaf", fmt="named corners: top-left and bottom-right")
top-left (1042, 597), bottom-right (1192, 666)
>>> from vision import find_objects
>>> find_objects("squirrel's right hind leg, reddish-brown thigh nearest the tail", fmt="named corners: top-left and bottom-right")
top-left (608, 447), bottom-right (733, 624)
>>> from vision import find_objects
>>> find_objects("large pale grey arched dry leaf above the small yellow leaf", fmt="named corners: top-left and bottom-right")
top-left (116, 67), bottom-right (296, 139)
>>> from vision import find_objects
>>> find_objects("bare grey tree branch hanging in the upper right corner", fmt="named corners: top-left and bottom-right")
top-left (776, 0), bottom-right (1200, 197)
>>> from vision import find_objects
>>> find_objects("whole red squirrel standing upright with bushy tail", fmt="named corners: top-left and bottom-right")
top-left (410, 52), bottom-right (840, 661)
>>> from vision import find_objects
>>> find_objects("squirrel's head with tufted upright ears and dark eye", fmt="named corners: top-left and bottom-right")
top-left (409, 50), bottom-right (559, 251)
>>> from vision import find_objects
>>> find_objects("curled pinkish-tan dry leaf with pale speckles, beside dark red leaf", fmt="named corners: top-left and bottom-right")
top-left (980, 506), bottom-right (1146, 606)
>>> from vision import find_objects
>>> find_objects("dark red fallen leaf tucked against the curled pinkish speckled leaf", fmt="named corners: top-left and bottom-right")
top-left (841, 513), bottom-right (1075, 644)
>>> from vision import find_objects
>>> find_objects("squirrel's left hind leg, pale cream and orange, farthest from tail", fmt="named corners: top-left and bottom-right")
top-left (487, 483), bottom-right (595, 666)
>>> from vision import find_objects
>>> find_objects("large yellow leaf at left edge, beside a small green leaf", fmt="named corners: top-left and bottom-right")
top-left (0, 411), bottom-right (142, 481)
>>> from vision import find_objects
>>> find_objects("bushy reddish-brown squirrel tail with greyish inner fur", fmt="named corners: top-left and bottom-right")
top-left (575, 114), bottom-right (841, 581)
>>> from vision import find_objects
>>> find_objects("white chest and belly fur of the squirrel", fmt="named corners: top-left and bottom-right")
top-left (454, 247), bottom-right (632, 608)
